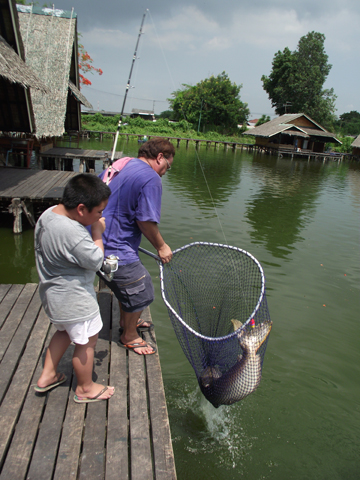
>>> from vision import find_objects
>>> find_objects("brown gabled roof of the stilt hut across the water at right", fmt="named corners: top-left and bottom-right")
top-left (245, 113), bottom-right (341, 144)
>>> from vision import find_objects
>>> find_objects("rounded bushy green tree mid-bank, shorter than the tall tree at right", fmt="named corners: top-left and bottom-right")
top-left (168, 72), bottom-right (250, 133)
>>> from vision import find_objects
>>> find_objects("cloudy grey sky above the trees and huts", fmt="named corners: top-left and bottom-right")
top-left (55, 0), bottom-right (360, 119)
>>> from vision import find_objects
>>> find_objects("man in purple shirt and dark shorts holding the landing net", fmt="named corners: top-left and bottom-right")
top-left (100, 138), bottom-right (175, 355)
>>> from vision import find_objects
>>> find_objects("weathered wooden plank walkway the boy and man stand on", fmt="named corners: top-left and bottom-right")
top-left (0, 284), bottom-right (176, 480)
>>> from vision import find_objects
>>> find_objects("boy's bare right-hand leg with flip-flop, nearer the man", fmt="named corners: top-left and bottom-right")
top-left (73, 334), bottom-right (114, 399)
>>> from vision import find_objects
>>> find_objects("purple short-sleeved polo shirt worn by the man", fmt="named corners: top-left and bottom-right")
top-left (99, 158), bottom-right (162, 265)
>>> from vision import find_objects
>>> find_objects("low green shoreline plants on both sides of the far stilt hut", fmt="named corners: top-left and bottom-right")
top-left (81, 112), bottom-right (354, 153)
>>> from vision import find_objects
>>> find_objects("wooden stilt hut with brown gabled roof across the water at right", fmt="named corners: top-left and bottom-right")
top-left (244, 113), bottom-right (341, 153)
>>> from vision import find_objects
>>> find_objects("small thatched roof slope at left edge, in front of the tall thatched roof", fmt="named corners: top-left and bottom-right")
top-left (0, 35), bottom-right (49, 93)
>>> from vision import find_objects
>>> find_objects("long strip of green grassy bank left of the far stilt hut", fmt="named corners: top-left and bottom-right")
top-left (81, 113), bottom-right (255, 143)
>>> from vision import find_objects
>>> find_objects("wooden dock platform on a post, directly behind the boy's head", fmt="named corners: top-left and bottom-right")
top-left (0, 167), bottom-right (77, 233)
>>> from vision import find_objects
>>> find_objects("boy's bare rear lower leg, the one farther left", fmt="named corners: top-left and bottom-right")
top-left (37, 330), bottom-right (71, 388)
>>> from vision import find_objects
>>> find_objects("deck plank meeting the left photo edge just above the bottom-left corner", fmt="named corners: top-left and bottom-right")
top-left (0, 309), bottom-right (49, 464)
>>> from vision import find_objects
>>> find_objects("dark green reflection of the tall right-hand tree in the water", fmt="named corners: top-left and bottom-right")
top-left (245, 156), bottom-right (322, 258)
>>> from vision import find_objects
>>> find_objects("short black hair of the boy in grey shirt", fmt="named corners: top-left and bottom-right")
top-left (60, 173), bottom-right (111, 212)
